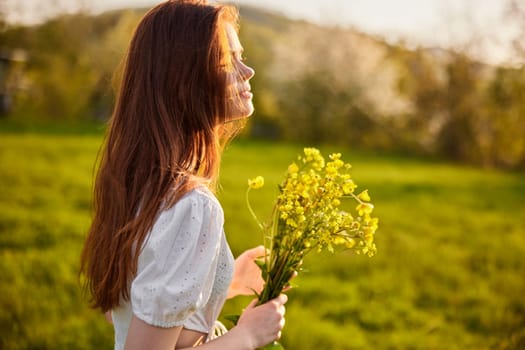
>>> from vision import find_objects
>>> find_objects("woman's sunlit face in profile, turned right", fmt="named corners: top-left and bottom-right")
top-left (226, 23), bottom-right (255, 119)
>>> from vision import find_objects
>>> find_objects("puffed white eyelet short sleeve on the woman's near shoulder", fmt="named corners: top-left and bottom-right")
top-left (131, 194), bottom-right (224, 327)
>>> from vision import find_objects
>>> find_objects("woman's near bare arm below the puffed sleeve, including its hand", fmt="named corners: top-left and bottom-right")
top-left (125, 294), bottom-right (287, 350)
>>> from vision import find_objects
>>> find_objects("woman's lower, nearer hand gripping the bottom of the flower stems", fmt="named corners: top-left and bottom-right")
top-left (234, 294), bottom-right (288, 349)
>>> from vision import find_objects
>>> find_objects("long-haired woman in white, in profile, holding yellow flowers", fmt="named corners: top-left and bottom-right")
top-left (81, 0), bottom-right (286, 350)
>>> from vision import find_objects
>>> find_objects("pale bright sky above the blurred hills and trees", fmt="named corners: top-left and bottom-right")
top-left (0, 0), bottom-right (525, 63)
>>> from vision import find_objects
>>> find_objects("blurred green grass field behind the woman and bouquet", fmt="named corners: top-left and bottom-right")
top-left (0, 131), bottom-right (525, 350)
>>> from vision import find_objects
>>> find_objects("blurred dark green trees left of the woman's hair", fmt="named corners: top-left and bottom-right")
top-left (1, 11), bottom-right (138, 121)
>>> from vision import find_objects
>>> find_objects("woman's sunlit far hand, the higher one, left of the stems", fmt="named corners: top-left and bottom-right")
top-left (228, 245), bottom-right (266, 298)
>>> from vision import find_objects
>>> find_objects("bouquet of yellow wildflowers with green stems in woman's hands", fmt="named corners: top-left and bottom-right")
top-left (246, 148), bottom-right (378, 348)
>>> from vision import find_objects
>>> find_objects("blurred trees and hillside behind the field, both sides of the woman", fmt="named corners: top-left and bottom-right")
top-left (0, 7), bottom-right (525, 168)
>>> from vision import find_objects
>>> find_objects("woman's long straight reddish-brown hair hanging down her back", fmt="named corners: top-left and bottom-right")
top-left (80, 0), bottom-right (242, 311)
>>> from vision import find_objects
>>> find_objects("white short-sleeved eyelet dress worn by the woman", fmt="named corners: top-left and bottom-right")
top-left (112, 188), bottom-right (234, 349)
